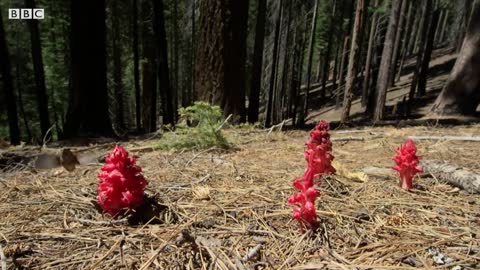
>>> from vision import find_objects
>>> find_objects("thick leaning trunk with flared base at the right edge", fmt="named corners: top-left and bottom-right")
top-left (431, 5), bottom-right (480, 115)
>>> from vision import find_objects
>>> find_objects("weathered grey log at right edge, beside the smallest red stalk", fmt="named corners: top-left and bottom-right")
top-left (421, 160), bottom-right (480, 193)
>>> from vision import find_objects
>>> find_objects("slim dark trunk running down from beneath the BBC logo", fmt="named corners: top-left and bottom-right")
top-left (25, 0), bottom-right (50, 140)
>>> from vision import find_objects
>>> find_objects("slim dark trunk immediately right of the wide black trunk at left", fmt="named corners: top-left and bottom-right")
top-left (112, 1), bottom-right (125, 132)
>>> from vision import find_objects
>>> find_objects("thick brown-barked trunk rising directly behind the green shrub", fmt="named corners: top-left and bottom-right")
top-left (195, 0), bottom-right (248, 122)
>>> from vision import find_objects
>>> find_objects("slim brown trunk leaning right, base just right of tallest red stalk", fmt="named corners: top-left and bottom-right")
top-left (340, 0), bottom-right (368, 123)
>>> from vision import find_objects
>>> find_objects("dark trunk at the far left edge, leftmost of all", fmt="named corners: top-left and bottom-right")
top-left (0, 7), bottom-right (20, 145)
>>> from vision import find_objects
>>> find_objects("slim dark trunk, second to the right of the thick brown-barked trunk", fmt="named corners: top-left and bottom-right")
top-left (265, 0), bottom-right (283, 126)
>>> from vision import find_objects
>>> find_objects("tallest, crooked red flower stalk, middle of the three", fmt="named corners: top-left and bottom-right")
top-left (288, 120), bottom-right (335, 231)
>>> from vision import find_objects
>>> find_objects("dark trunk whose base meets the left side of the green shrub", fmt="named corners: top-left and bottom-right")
top-left (152, 0), bottom-right (176, 125)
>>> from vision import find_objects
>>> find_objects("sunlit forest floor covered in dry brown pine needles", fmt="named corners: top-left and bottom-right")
top-left (0, 125), bottom-right (480, 270)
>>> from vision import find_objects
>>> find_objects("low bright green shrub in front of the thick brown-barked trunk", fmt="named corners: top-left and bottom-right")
top-left (158, 102), bottom-right (231, 149)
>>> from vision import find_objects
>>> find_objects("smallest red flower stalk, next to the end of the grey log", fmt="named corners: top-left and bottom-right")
top-left (393, 139), bottom-right (423, 191)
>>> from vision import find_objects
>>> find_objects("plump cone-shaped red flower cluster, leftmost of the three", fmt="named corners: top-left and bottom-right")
top-left (97, 145), bottom-right (147, 216)
